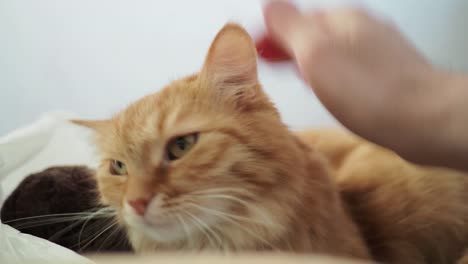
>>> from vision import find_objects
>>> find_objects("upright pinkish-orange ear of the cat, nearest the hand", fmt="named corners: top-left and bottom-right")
top-left (200, 24), bottom-right (260, 101)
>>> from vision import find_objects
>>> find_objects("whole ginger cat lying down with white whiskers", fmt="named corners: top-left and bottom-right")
top-left (74, 24), bottom-right (468, 263)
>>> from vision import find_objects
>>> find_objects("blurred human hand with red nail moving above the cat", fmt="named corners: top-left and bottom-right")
top-left (258, 1), bottom-right (468, 169)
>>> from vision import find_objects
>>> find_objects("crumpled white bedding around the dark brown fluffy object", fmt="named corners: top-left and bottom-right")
top-left (0, 113), bottom-right (96, 264)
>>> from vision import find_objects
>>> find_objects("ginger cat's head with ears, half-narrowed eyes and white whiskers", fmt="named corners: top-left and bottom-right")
top-left (75, 24), bottom-right (308, 250)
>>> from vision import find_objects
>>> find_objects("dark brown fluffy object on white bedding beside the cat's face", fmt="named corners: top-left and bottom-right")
top-left (1, 166), bottom-right (131, 253)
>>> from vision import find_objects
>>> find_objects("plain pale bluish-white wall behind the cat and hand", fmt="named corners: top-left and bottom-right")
top-left (0, 0), bottom-right (468, 136)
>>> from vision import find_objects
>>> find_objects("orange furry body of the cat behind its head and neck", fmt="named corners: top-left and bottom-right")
top-left (299, 129), bottom-right (468, 263)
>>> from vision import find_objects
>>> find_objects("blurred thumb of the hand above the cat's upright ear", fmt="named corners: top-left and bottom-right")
top-left (263, 1), bottom-right (303, 57)
